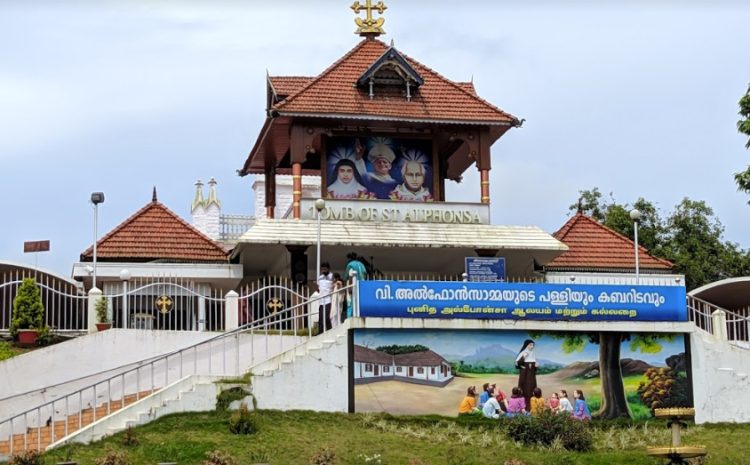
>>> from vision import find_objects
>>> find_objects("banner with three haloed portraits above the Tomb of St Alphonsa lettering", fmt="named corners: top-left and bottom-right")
top-left (326, 137), bottom-right (434, 202)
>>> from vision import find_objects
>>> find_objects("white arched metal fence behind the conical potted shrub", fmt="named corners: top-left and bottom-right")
top-left (0, 270), bottom-right (88, 333)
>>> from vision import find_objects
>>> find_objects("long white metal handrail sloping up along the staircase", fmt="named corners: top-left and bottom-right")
top-left (0, 285), bottom-right (354, 450)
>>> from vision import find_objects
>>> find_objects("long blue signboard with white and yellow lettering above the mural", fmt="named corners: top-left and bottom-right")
top-left (359, 281), bottom-right (687, 321)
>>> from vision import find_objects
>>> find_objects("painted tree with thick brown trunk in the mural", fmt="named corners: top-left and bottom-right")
top-left (531, 331), bottom-right (673, 419)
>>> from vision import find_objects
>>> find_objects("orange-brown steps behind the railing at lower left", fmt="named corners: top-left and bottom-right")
top-left (0, 391), bottom-right (153, 460)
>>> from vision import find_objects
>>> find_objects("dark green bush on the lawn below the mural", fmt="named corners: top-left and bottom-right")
top-left (508, 412), bottom-right (593, 451)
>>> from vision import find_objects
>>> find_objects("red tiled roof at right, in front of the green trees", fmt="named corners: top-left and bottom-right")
top-left (546, 212), bottom-right (673, 271)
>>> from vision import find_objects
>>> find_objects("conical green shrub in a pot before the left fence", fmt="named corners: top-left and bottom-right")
top-left (9, 278), bottom-right (44, 347)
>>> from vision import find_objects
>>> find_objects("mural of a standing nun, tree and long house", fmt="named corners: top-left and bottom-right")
top-left (351, 330), bottom-right (692, 418)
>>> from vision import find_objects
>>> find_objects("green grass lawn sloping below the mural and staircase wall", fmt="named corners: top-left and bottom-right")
top-left (36, 411), bottom-right (750, 465)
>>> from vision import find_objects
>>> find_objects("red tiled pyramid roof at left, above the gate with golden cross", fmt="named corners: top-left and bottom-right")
top-left (81, 200), bottom-right (228, 263)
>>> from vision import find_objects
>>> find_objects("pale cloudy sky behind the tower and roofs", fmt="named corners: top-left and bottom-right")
top-left (0, 0), bottom-right (750, 275)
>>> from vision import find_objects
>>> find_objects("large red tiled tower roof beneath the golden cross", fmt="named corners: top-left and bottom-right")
top-left (272, 39), bottom-right (518, 125)
